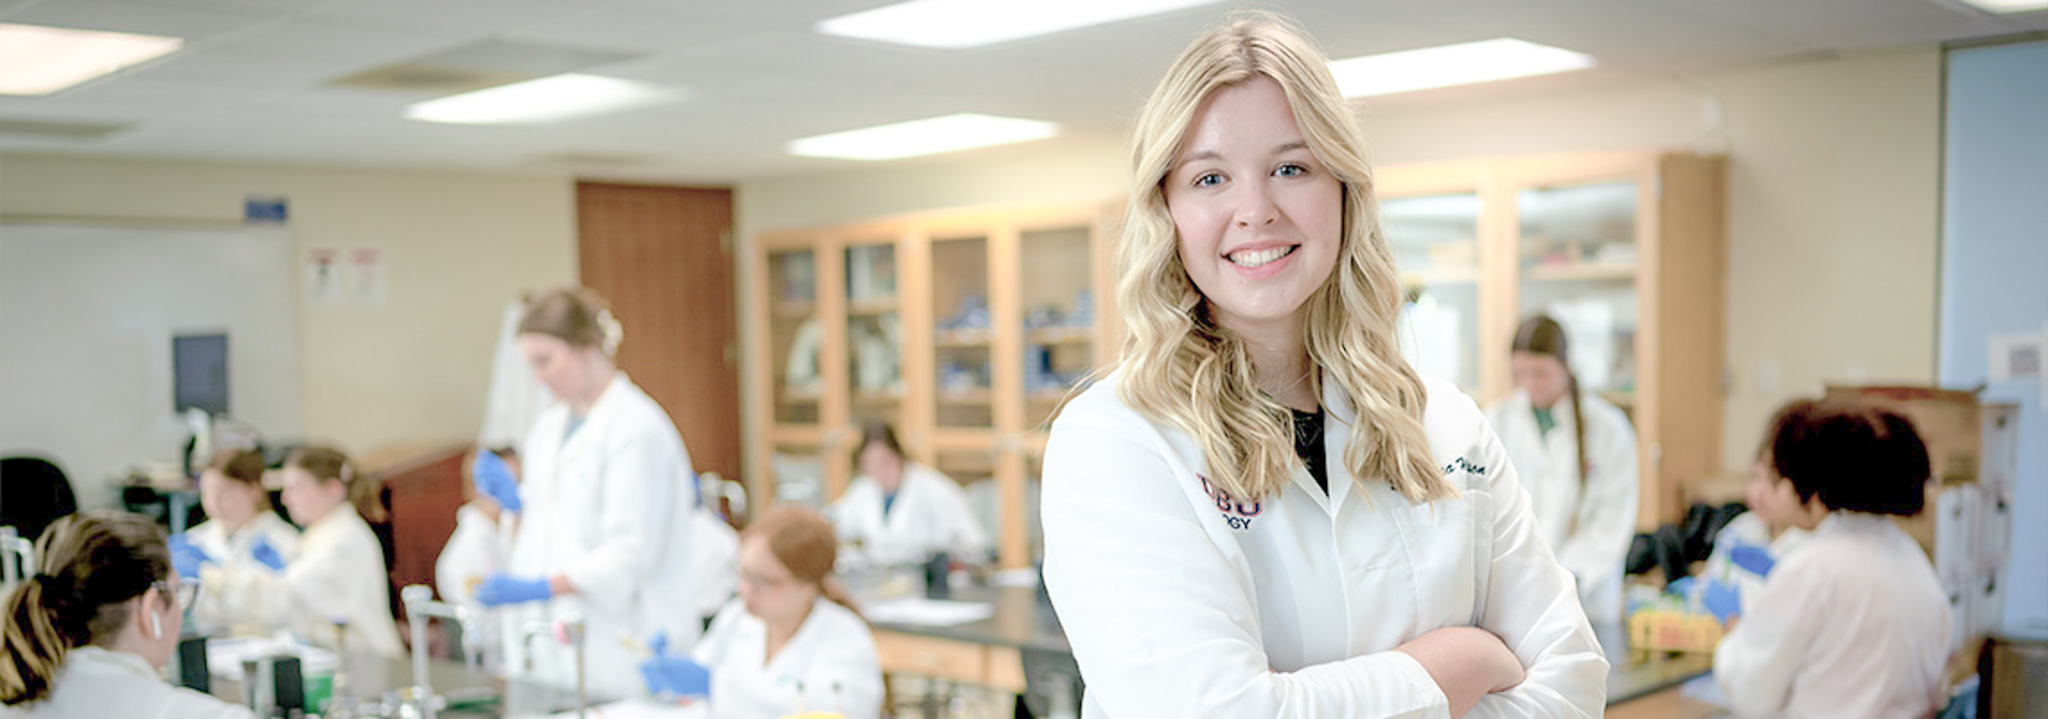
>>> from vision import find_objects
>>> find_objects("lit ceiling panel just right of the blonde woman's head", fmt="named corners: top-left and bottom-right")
top-left (1329, 37), bottom-right (1593, 98)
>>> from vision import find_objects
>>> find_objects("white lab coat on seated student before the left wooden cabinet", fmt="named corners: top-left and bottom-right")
top-left (831, 461), bottom-right (989, 563)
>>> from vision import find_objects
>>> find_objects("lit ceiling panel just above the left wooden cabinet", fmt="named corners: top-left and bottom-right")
top-left (788, 113), bottom-right (1059, 160)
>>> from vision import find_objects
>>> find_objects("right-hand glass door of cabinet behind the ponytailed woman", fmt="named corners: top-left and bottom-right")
top-left (1516, 180), bottom-right (1638, 410)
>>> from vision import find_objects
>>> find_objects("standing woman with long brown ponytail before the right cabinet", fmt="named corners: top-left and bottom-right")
top-left (1487, 315), bottom-right (1642, 625)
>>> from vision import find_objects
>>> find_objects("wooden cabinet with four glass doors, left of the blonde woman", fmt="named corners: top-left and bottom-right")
top-left (743, 203), bottom-right (1118, 567)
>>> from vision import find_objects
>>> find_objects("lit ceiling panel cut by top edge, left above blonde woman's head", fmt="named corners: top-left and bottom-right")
top-left (817, 0), bottom-right (1221, 49)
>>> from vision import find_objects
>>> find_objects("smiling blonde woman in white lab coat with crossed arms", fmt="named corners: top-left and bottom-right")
top-left (1042, 14), bottom-right (1608, 717)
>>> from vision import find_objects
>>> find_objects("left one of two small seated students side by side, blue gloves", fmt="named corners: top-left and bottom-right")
top-left (172, 449), bottom-right (299, 633)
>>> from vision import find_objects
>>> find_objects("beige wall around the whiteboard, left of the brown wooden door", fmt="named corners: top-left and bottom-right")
top-left (0, 154), bottom-right (578, 501)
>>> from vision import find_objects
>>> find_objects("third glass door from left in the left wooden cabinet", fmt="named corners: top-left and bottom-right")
top-left (932, 238), bottom-right (995, 428)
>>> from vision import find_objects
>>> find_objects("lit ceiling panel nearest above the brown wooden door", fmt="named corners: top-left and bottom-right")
top-left (406, 72), bottom-right (682, 125)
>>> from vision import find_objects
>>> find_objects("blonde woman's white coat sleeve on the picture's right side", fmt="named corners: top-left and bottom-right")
top-left (1474, 407), bottom-right (1608, 717)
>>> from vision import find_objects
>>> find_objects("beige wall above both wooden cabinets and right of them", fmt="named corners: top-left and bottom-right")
top-left (737, 47), bottom-right (1942, 469)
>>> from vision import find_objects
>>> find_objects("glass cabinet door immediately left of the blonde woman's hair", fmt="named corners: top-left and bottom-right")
top-left (1018, 225), bottom-right (1096, 430)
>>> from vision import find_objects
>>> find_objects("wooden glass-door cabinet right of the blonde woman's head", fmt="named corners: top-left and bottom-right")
top-left (1376, 152), bottom-right (1726, 528)
